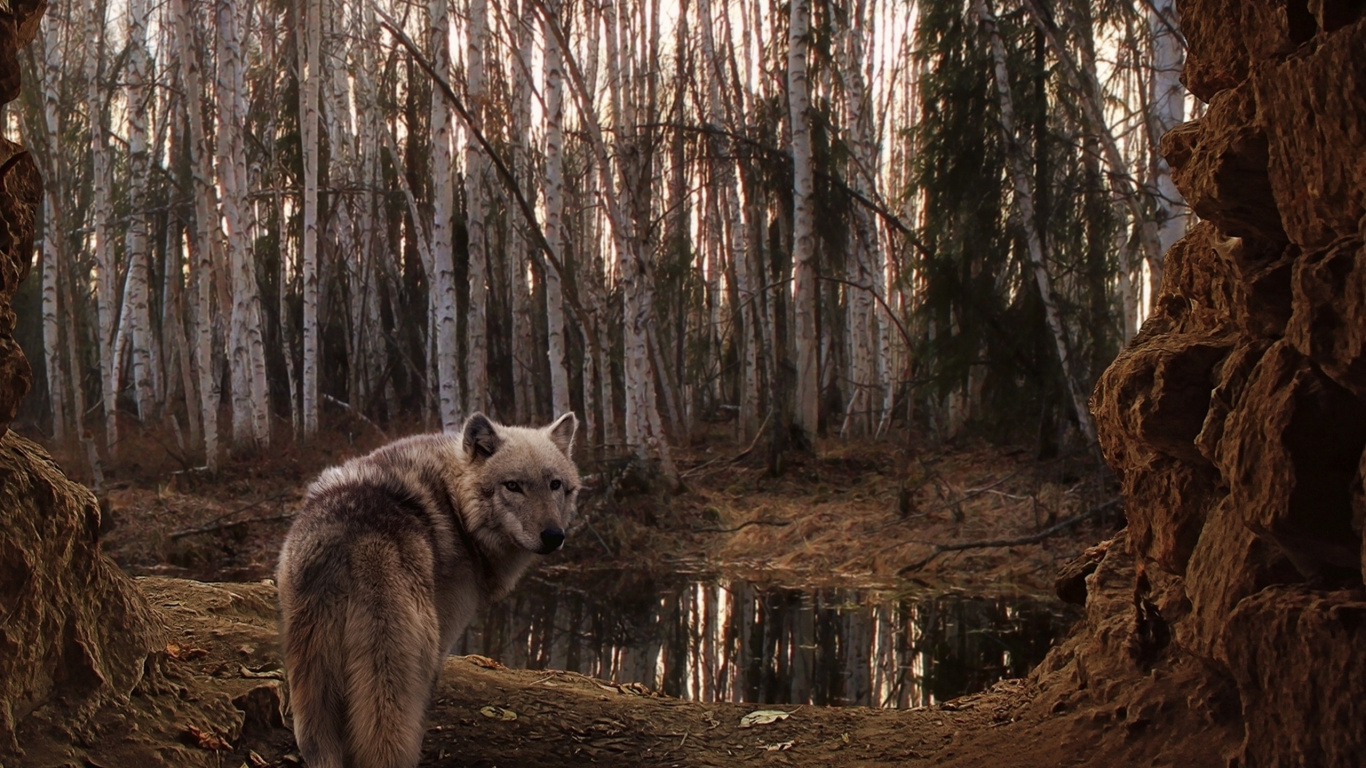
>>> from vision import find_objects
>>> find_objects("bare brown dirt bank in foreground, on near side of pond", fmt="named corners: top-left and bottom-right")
top-left (7, 563), bottom-right (1228, 768)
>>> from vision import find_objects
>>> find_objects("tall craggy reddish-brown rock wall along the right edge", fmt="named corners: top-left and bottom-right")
top-left (1089, 0), bottom-right (1366, 767)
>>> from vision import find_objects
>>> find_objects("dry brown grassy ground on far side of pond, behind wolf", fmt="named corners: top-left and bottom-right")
top-left (85, 423), bottom-right (1123, 596)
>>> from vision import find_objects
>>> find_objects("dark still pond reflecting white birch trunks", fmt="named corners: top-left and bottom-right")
top-left (456, 573), bottom-right (1071, 707)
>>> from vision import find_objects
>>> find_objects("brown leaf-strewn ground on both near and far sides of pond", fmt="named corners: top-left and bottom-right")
top-left (20, 431), bottom-right (1185, 768)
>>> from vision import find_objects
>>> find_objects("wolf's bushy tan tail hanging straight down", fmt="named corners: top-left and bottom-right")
top-left (340, 541), bottom-right (441, 768)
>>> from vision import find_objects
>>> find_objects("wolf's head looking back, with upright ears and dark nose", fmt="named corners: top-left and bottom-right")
top-left (460, 413), bottom-right (579, 555)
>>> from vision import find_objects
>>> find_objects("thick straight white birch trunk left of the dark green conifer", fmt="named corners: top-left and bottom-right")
top-left (787, 0), bottom-right (821, 445)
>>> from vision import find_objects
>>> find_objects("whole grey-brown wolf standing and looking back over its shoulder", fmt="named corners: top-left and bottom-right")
top-left (276, 413), bottom-right (579, 768)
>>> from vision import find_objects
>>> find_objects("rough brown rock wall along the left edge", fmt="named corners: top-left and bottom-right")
top-left (0, 0), bottom-right (157, 764)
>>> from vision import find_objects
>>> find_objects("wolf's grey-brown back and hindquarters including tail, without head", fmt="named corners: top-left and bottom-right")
top-left (279, 480), bottom-right (441, 768)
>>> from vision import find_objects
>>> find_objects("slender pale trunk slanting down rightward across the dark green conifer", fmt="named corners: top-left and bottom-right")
top-left (973, 0), bottom-right (1096, 445)
